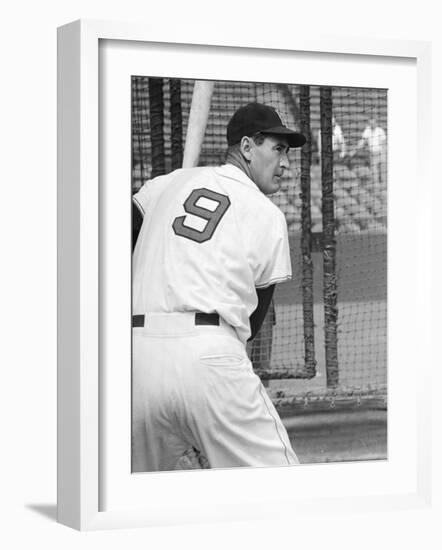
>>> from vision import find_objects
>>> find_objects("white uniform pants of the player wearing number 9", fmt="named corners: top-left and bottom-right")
top-left (132, 313), bottom-right (298, 472)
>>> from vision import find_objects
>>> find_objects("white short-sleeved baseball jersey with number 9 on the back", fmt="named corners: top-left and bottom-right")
top-left (133, 164), bottom-right (291, 342)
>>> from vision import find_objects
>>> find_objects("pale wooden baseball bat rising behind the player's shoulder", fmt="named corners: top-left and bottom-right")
top-left (183, 80), bottom-right (214, 168)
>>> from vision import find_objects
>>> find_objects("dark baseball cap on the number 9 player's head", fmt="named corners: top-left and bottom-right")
top-left (227, 103), bottom-right (306, 147)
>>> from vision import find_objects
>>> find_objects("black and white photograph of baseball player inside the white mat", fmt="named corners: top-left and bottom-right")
top-left (127, 75), bottom-right (389, 473)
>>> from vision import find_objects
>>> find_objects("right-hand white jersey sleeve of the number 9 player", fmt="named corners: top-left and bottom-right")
top-left (255, 204), bottom-right (292, 288)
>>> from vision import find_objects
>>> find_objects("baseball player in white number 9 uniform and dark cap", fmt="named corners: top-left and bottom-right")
top-left (132, 103), bottom-right (305, 472)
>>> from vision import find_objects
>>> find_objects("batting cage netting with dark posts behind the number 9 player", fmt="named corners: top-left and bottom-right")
top-left (132, 76), bottom-right (387, 414)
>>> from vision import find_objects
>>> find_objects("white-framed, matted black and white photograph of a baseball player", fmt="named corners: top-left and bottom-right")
top-left (58, 21), bottom-right (431, 530)
